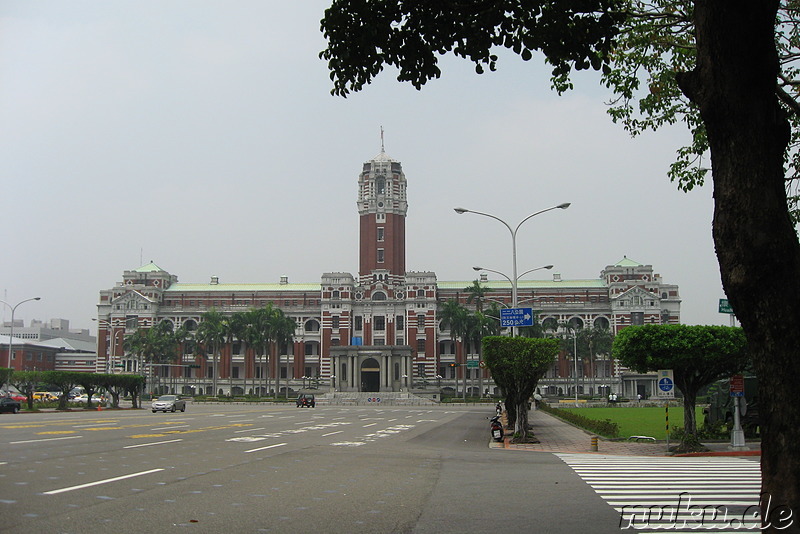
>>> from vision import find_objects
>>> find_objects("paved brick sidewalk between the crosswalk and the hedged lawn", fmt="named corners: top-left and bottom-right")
top-left (492, 410), bottom-right (761, 456)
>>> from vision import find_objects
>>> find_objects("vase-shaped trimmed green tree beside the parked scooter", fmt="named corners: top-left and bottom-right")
top-left (483, 336), bottom-right (558, 440)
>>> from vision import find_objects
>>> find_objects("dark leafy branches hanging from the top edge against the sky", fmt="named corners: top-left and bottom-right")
top-left (320, 0), bottom-right (624, 96)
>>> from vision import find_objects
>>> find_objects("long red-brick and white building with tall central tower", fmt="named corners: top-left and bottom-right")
top-left (97, 146), bottom-right (680, 395)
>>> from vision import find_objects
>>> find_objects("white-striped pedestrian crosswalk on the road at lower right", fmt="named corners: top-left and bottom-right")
top-left (557, 454), bottom-right (761, 533)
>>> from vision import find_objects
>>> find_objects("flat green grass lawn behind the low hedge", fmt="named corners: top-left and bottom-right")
top-left (559, 406), bottom-right (704, 439)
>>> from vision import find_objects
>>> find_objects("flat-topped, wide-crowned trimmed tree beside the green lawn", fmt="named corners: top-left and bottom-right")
top-left (613, 325), bottom-right (750, 451)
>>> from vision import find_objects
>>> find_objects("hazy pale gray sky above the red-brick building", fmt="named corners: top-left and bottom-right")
top-left (0, 0), bottom-right (729, 336)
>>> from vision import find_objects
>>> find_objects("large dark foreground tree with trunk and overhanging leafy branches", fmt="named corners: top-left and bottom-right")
top-left (320, 0), bottom-right (800, 525)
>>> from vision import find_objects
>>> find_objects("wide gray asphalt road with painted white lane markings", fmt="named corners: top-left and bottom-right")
top-left (0, 404), bottom-right (619, 534)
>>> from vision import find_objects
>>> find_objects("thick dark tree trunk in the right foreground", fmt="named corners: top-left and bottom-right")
top-left (678, 0), bottom-right (800, 532)
